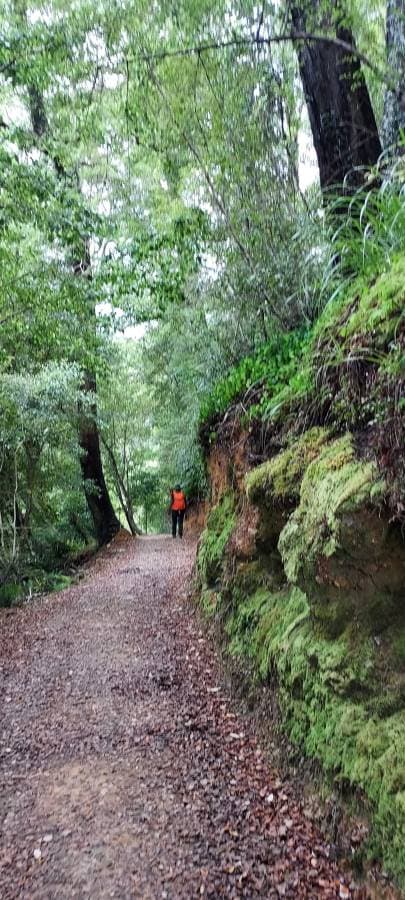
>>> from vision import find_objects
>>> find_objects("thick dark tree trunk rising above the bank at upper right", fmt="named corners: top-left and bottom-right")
top-left (291, 0), bottom-right (381, 192)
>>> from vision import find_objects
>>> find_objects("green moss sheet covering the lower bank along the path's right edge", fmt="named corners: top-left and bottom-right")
top-left (218, 572), bottom-right (405, 883)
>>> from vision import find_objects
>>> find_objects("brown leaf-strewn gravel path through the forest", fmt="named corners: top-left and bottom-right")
top-left (0, 536), bottom-right (365, 900)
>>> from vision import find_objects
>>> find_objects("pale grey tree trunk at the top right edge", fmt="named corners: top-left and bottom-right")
top-left (381, 0), bottom-right (405, 152)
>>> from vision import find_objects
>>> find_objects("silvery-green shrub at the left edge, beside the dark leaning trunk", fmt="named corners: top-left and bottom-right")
top-left (0, 362), bottom-right (91, 592)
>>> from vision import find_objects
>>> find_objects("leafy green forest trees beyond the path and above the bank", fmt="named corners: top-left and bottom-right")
top-left (0, 0), bottom-right (404, 598)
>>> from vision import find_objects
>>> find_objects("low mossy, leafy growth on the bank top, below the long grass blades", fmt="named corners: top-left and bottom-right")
top-left (201, 256), bottom-right (405, 519)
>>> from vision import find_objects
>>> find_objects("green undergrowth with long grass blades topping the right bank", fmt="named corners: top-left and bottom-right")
top-left (200, 157), bottom-right (405, 478)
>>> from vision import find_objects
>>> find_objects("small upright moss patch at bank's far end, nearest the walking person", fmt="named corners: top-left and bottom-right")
top-left (197, 491), bottom-right (236, 587)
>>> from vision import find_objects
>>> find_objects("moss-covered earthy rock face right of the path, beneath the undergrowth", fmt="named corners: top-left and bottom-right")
top-left (198, 264), bottom-right (405, 885)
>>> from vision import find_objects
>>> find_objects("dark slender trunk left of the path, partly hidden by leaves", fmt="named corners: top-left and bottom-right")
top-left (24, 67), bottom-right (121, 545)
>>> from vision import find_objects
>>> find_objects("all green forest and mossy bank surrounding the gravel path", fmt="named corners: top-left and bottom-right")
top-left (0, 0), bottom-right (405, 896)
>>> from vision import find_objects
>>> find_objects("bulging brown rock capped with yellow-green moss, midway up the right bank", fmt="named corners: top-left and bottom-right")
top-left (278, 434), bottom-right (405, 634)
